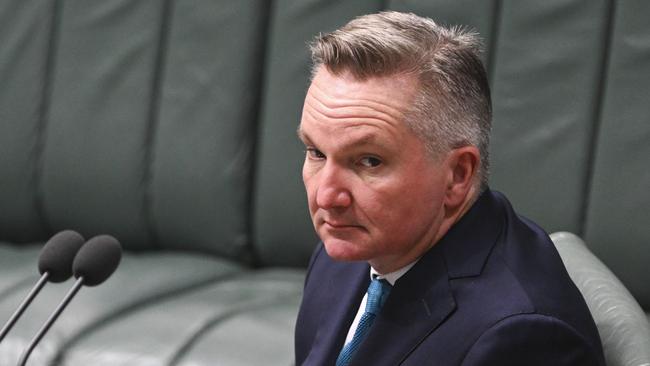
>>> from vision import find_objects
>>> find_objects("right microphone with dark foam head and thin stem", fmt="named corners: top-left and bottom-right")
top-left (18, 235), bottom-right (122, 366)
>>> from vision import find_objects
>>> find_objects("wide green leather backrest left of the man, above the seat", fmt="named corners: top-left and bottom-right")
top-left (0, 0), bottom-right (268, 258)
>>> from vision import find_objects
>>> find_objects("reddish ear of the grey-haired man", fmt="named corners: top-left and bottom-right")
top-left (445, 146), bottom-right (481, 212)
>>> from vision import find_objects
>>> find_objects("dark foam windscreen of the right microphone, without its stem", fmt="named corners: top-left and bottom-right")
top-left (72, 235), bottom-right (122, 286)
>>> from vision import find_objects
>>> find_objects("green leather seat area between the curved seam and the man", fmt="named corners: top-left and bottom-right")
top-left (54, 270), bottom-right (304, 366)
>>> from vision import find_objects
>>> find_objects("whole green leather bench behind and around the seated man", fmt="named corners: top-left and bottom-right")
top-left (0, 0), bottom-right (650, 366)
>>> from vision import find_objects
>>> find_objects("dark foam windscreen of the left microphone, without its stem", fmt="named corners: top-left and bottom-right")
top-left (38, 230), bottom-right (84, 282)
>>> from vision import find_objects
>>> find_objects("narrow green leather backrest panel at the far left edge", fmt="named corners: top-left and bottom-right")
top-left (0, 0), bottom-right (54, 242)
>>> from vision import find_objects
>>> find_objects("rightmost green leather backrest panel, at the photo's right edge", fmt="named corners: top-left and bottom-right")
top-left (585, 1), bottom-right (650, 311)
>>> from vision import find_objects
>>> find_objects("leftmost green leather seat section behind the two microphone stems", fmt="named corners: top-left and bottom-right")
top-left (0, 246), bottom-right (241, 366)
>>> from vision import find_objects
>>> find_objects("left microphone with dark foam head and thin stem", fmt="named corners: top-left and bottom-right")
top-left (0, 230), bottom-right (84, 342)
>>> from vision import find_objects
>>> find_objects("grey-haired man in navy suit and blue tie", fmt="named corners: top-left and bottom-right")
top-left (295, 12), bottom-right (604, 366)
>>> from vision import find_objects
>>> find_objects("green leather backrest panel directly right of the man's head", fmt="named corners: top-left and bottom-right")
top-left (491, 0), bottom-right (609, 233)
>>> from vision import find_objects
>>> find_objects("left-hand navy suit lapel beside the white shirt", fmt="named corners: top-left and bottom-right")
top-left (303, 262), bottom-right (370, 365)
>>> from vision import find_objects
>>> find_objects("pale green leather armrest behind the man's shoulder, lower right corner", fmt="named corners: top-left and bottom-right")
top-left (551, 232), bottom-right (650, 366)
